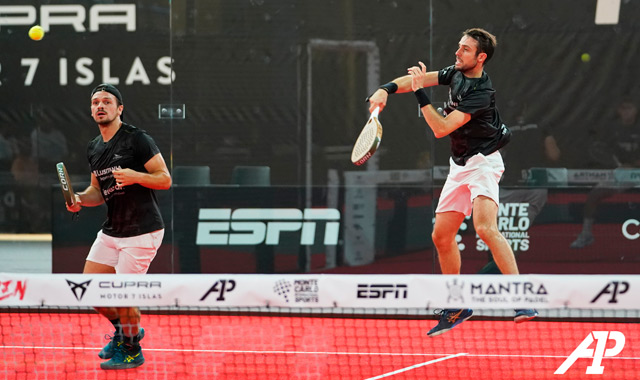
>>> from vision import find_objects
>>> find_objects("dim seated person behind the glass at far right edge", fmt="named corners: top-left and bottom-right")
top-left (570, 96), bottom-right (640, 249)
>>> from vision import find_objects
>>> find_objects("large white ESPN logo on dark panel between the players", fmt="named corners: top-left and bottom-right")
top-left (196, 208), bottom-right (340, 245)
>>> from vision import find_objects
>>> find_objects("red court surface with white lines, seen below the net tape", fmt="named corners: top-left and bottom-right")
top-left (0, 312), bottom-right (640, 380)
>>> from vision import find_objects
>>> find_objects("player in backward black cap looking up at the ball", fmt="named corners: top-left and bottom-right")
top-left (67, 84), bottom-right (171, 369)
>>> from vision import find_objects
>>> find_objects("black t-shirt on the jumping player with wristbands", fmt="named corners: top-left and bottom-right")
top-left (438, 66), bottom-right (511, 165)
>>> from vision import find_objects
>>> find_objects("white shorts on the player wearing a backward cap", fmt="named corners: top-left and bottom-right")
top-left (87, 229), bottom-right (164, 274)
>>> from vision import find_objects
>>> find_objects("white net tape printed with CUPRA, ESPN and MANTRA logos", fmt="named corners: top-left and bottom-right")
top-left (0, 273), bottom-right (640, 310)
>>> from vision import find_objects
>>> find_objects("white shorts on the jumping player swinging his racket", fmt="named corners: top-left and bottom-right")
top-left (436, 151), bottom-right (504, 216)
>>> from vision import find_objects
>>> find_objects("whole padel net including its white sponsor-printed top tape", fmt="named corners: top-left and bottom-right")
top-left (0, 273), bottom-right (640, 380)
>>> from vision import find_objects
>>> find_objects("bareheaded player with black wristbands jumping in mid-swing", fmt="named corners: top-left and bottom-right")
top-left (369, 28), bottom-right (538, 336)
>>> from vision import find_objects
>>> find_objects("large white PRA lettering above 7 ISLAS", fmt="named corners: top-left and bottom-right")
top-left (0, 4), bottom-right (136, 32)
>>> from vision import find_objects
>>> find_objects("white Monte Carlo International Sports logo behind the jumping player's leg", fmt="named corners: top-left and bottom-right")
top-left (476, 203), bottom-right (531, 252)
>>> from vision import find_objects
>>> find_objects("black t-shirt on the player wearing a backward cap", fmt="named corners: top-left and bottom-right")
top-left (87, 123), bottom-right (164, 237)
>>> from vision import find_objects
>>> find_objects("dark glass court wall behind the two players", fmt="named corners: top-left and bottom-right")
top-left (0, 0), bottom-right (640, 273)
